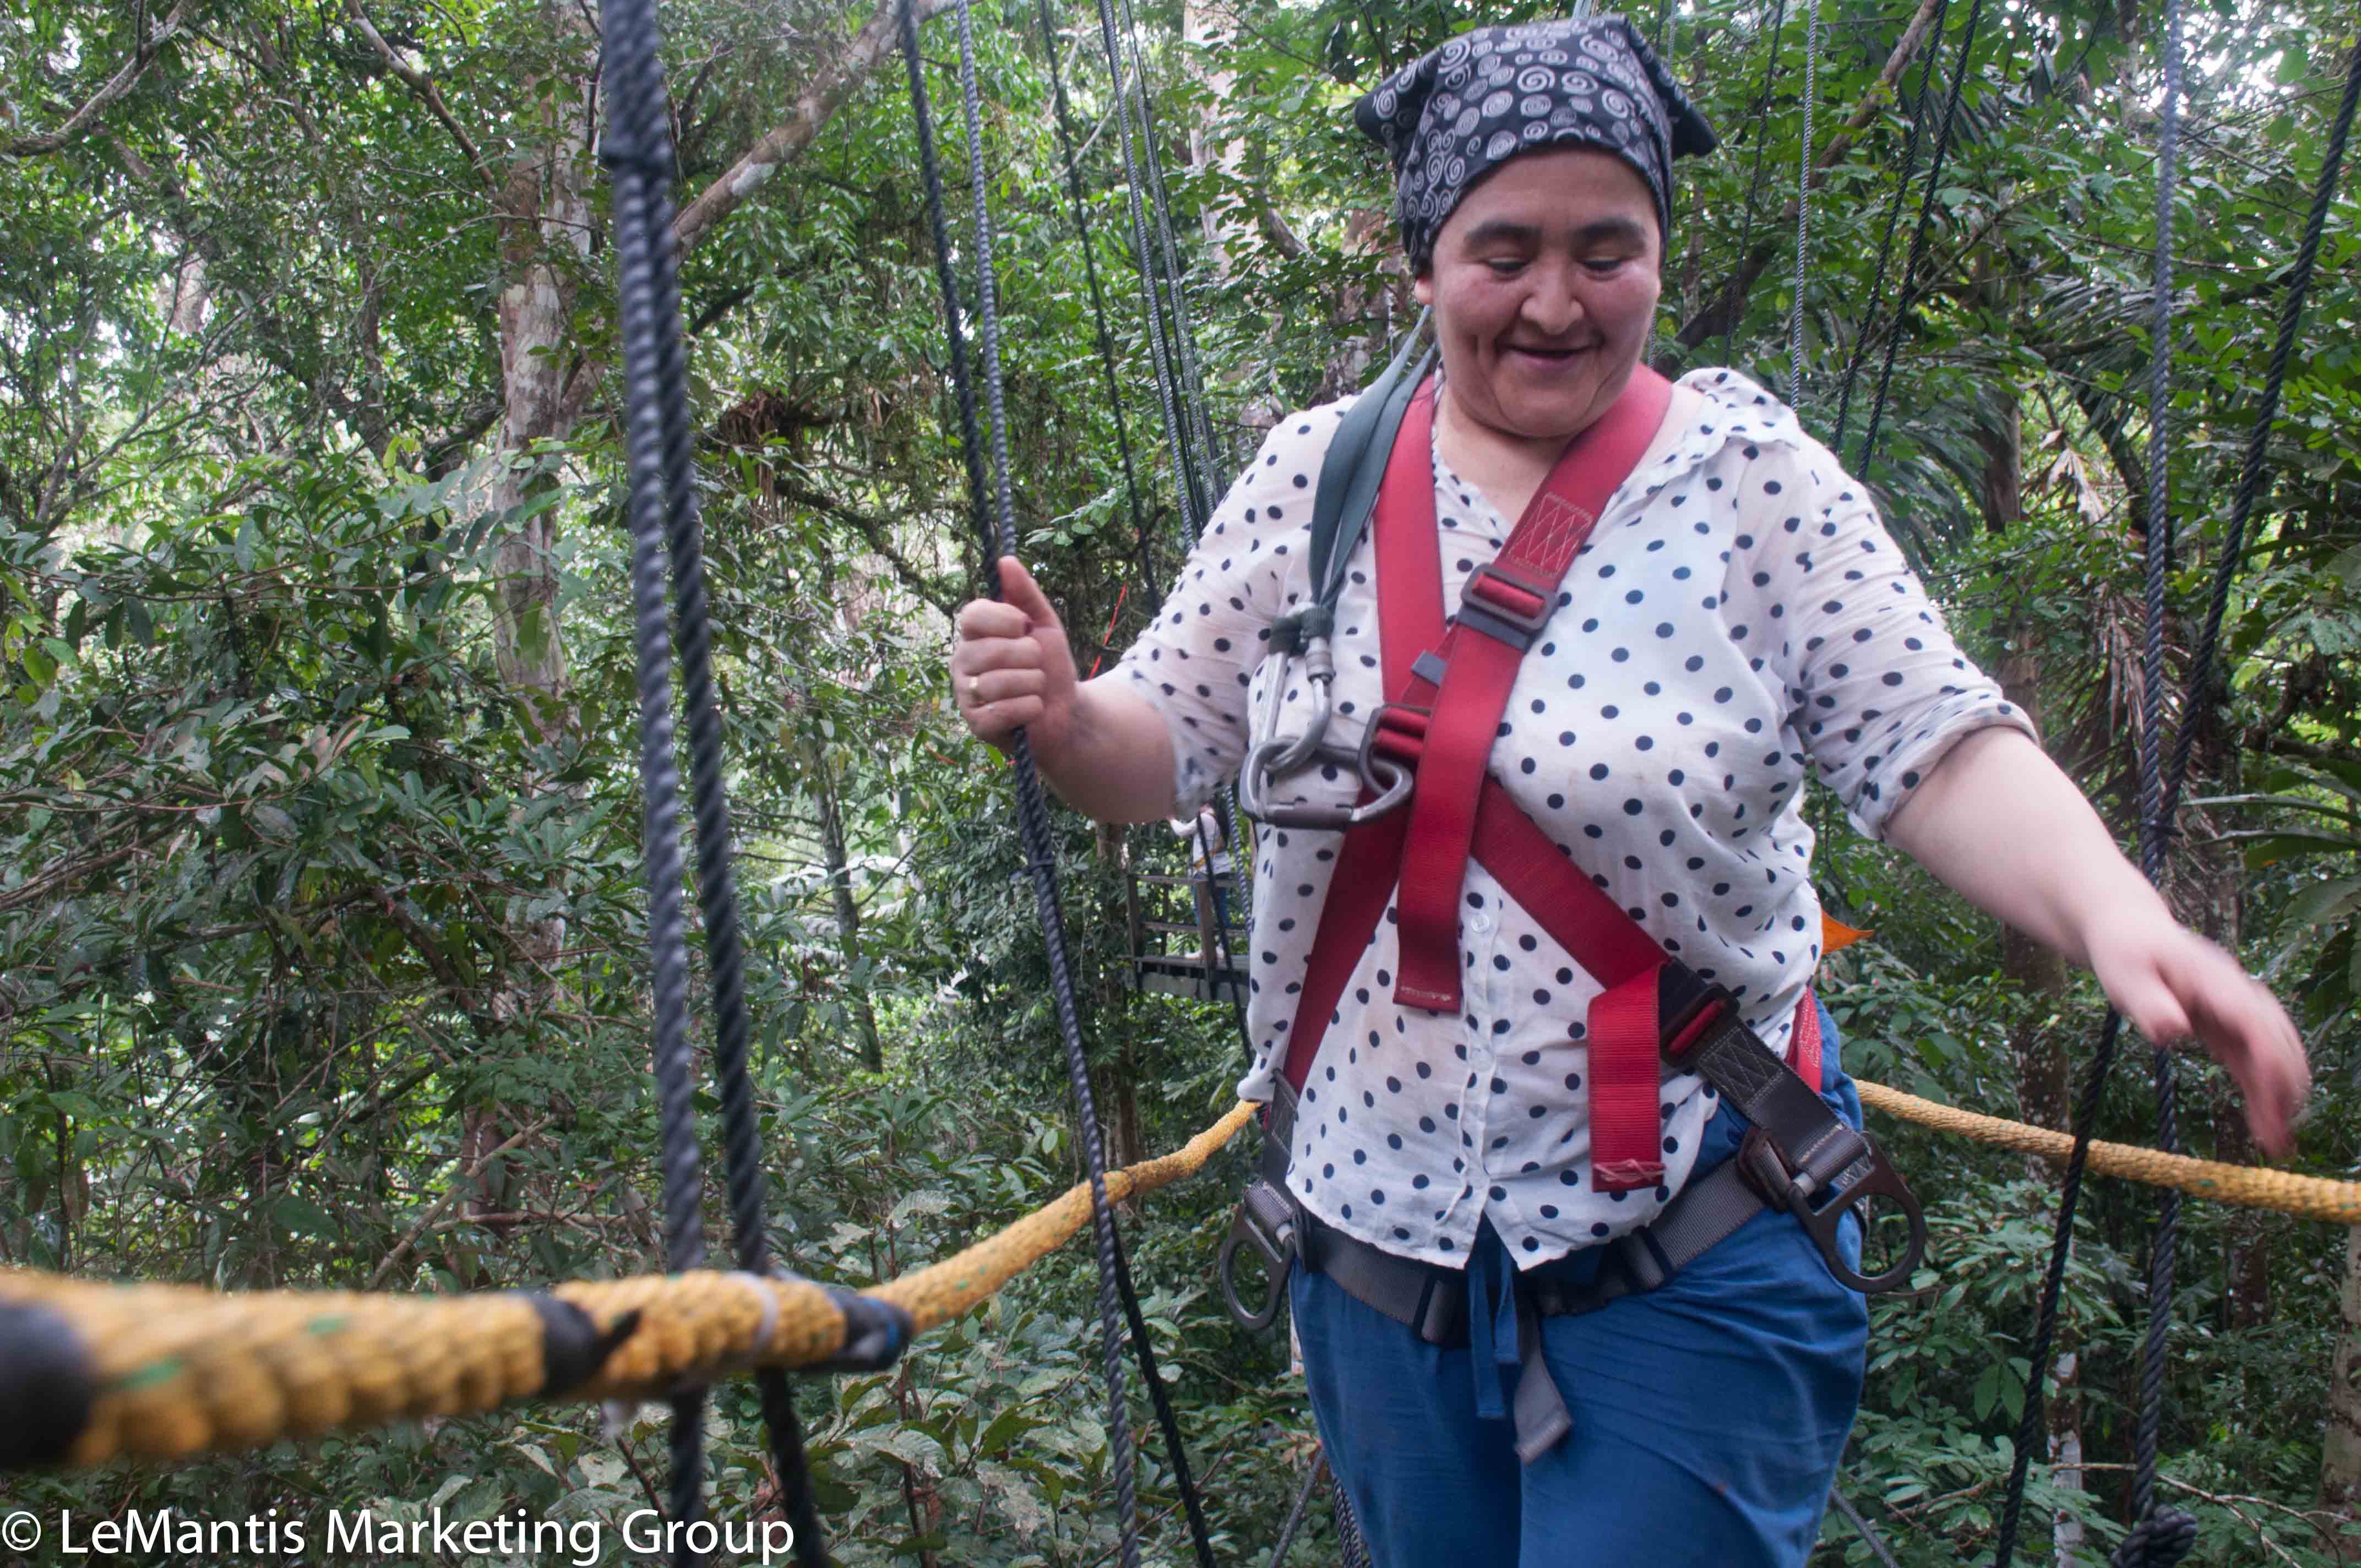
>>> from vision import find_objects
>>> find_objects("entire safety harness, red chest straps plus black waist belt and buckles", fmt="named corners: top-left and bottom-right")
top-left (1218, 359), bottom-right (1924, 1389)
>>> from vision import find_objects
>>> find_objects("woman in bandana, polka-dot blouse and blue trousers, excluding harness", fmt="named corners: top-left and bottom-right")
top-left (951, 19), bottom-right (2306, 1568)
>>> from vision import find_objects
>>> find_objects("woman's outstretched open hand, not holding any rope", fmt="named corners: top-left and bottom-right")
top-left (2085, 900), bottom-right (2311, 1159)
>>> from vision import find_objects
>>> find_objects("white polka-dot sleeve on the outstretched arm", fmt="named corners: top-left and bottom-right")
top-left (1726, 439), bottom-right (2038, 839)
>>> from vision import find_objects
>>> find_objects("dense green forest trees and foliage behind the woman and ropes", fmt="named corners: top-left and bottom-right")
top-left (0, 0), bottom-right (2361, 1568)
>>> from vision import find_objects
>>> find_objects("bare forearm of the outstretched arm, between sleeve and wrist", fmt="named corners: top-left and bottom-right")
top-left (1886, 727), bottom-right (2163, 963)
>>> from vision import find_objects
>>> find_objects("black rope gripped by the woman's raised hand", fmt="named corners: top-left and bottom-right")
top-left (900, 0), bottom-right (1140, 1568)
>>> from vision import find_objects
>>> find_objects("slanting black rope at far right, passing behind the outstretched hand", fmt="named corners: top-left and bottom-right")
top-left (1993, 21), bottom-right (2361, 1568)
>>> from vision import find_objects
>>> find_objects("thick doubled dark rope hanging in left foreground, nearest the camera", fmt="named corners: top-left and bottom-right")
top-left (602, 0), bottom-right (829, 1568)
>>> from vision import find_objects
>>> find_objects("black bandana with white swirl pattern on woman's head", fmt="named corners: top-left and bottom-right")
top-left (1353, 17), bottom-right (1714, 271)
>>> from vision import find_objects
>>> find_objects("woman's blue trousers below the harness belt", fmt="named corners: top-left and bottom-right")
top-left (1289, 1008), bottom-right (1868, 1568)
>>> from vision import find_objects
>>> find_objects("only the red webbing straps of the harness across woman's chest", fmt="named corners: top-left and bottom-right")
top-left (1285, 366), bottom-right (1820, 1193)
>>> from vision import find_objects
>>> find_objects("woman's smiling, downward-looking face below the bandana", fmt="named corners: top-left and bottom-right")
top-left (1417, 146), bottom-right (1662, 442)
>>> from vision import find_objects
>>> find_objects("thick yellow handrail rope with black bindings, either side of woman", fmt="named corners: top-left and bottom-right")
top-left (0, 1079), bottom-right (2361, 1469)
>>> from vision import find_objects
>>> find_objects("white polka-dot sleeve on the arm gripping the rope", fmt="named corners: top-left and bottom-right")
top-left (1109, 404), bottom-right (1346, 817)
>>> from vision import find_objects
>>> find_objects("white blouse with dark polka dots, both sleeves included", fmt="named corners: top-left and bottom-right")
top-left (1114, 371), bottom-right (2033, 1266)
